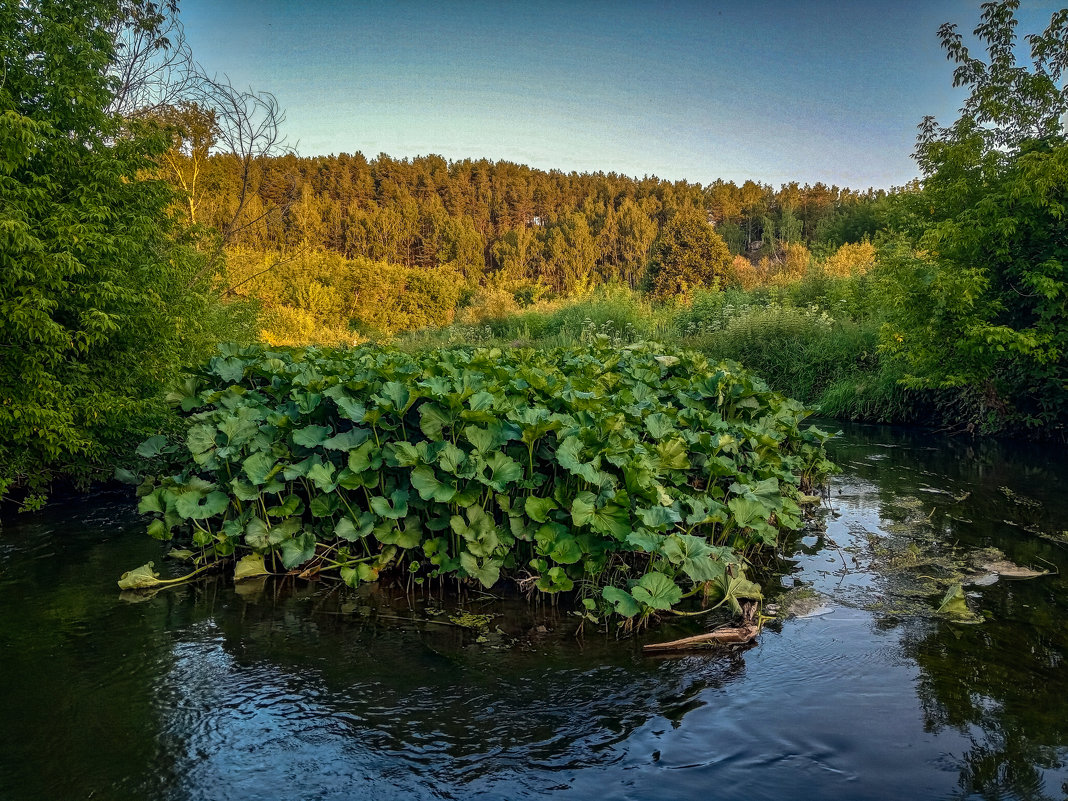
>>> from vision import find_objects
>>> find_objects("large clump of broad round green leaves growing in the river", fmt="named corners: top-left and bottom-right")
top-left (128, 337), bottom-right (832, 619)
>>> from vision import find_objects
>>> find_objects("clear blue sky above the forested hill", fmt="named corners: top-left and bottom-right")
top-left (180, 0), bottom-right (1059, 189)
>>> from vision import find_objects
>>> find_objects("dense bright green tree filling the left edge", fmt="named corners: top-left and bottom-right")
top-left (0, 0), bottom-right (252, 504)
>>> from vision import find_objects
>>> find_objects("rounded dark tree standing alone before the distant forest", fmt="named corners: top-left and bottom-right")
top-left (646, 208), bottom-right (732, 299)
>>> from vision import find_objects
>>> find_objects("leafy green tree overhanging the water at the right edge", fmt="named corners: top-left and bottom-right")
top-left (885, 0), bottom-right (1068, 436)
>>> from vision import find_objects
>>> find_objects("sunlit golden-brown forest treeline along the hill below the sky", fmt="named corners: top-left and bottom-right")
top-left (177, 147), bottom-right (886, 294)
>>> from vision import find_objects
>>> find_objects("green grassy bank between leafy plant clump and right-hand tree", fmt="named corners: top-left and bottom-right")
top-left (398, 280), bottom-right (932, 423)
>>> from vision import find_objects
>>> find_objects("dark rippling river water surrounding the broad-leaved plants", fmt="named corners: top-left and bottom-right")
top-left (0, 427), bottom-right (1068, 801)
